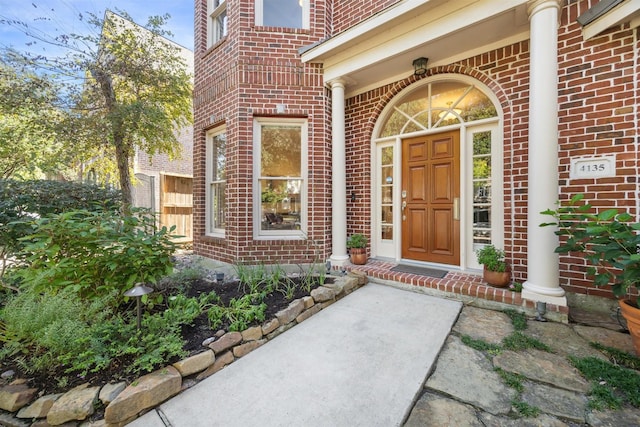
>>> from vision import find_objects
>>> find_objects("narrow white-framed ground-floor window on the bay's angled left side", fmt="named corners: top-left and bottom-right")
top-left (206, 128), bottom-right (227, 237)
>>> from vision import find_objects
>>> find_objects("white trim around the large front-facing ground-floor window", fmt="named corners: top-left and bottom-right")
top-left (253, 117), bottom-right (309, 240)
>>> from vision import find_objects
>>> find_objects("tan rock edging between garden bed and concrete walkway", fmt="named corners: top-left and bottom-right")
top-left (0, 271), bottom-right (367, 427)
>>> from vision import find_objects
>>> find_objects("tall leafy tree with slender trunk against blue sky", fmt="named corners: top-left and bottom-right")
top-left (0, 7), bottom-right (192, 206)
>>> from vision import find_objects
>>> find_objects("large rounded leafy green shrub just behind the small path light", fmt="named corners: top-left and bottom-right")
top-left (11, 210), bottom-right (176, 298)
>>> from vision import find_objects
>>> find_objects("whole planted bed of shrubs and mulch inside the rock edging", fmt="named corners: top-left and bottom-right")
top-left (0, 202), bottom-right (325, 393)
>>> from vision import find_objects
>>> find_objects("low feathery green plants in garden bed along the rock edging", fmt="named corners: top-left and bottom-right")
top-left (0, 289), bottom-right (217, 382)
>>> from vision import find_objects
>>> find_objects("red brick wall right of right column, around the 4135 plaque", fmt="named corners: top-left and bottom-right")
top-left (558, 1), bottom-right (640, 296)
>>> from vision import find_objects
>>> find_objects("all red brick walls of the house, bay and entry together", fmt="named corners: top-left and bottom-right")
top-left (194, 0), bottom-right (640, 295)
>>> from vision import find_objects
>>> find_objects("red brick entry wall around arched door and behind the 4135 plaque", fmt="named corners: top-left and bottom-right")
top-left (346, 1), bottom-right (640, 296)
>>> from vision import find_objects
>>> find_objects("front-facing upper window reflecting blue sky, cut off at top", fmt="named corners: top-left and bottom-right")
top-left (255, 0), bottom-right (310, 29)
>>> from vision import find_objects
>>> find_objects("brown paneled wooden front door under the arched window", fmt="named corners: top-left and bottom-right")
top-left (401, 131), bottom-right (460, 265)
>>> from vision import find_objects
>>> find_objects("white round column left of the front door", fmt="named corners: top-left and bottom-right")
top-left (329, 79), bottom-right (349, 266)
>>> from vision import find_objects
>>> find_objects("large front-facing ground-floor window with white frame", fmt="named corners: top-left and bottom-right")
top-left (253, 118), bottom-right (307, 238)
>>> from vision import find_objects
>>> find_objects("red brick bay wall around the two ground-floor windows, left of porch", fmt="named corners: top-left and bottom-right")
top-left (194, 0), bottom-right (331, 263)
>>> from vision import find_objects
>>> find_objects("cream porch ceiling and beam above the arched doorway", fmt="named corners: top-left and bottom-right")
top-left (301, 0), bottom-right (529, 96)
